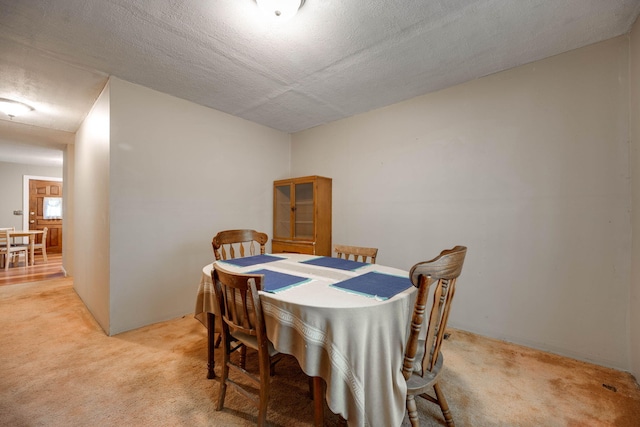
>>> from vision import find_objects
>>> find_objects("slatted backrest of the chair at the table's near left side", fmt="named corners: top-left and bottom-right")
top-left (211, 267), bottom-right (268, 350)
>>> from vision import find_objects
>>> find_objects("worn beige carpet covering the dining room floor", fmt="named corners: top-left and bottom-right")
top-left (0, 279), bottom-right (640, 427)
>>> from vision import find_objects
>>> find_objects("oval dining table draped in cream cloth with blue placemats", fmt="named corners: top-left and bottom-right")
top-left (195, 253), bottom-right (416, 426)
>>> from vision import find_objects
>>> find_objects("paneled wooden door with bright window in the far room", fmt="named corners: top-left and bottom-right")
top-left (28, 179), bottom-right (62, 253)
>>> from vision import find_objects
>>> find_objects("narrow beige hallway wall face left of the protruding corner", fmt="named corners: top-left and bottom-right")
top-left (74, 84), bottom-right (111, 332)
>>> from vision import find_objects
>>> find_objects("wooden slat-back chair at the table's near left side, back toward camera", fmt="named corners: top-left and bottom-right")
top-left (211, 267), bottom-right (282, 426)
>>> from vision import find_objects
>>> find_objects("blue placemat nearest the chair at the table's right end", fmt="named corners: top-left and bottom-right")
top-left (331, 271), bottom-right (413, 300)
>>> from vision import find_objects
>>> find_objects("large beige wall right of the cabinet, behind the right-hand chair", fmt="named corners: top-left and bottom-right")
top-left (292, 37), bottom-right (631, 370)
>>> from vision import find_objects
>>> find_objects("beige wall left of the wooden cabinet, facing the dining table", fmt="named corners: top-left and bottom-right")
top-left (105, 78), bottom-right (290, 334)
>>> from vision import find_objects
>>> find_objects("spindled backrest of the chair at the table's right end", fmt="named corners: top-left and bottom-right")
top-left (402, 246), bottom-right (467, 379)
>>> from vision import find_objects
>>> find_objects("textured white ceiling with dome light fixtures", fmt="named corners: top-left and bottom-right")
top-left (0, 0), bottom-right (640, 164)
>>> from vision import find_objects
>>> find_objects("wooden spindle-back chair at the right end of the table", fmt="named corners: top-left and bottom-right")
top-left (402, 246), bottom-right (467, 427)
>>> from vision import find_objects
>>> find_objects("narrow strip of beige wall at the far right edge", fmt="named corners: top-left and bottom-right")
top-left (629, 16), bottom-right (640, 380)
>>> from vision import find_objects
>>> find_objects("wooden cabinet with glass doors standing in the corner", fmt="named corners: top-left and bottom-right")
top-left (271, 176), bottom-right (332, 256)
